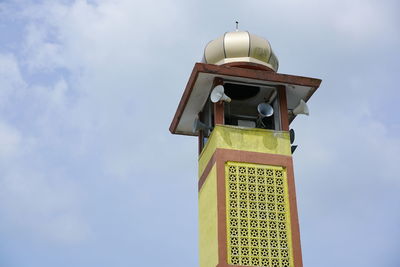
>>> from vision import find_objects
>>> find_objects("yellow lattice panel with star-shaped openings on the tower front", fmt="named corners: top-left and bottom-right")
top-left (225, 162), bottom-right (293, 267)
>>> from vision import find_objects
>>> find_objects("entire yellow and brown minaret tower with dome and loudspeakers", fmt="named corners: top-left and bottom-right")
top-left (170, 30), bottom-right (321, 267)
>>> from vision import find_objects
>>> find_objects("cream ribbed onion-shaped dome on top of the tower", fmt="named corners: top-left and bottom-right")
top-left (203, 31), bottom-right (279, 72)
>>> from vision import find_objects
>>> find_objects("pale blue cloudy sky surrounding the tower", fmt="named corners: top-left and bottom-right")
top-left (0, 0), bottom-right (400, 267)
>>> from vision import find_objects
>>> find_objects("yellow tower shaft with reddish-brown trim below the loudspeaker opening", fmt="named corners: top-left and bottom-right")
top-left (198, 125), bottom-right (302, 267)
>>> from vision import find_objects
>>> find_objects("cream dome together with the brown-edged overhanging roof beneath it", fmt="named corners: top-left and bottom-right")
top-left (169, 31), bottom-right (321, 135)
